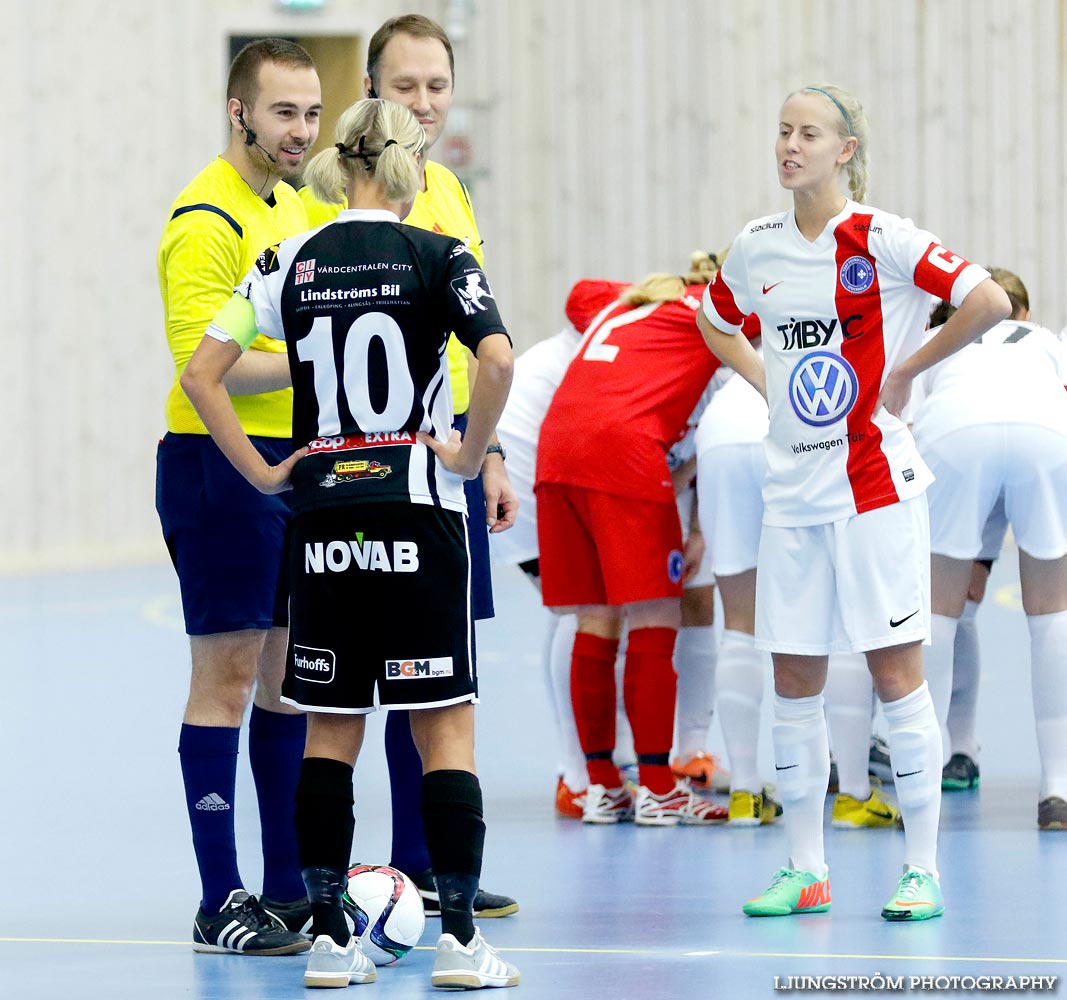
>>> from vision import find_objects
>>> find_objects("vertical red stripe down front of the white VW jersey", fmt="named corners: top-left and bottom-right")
top-left (834, 215), bottom-right (899, 513)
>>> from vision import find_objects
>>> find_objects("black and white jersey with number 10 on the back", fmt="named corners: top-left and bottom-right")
top-left (237, 209), bottom-right (507, 511)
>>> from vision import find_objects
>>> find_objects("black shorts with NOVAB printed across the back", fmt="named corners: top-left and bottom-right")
top-left (282, 503), bottom-right (478, 714)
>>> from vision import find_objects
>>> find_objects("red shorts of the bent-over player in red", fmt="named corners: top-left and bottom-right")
top-left (537, 482), bottom-right (684, 607)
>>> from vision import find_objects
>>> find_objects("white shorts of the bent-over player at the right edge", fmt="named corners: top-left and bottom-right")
top-left (923, 424), bottom-right (1067, 559)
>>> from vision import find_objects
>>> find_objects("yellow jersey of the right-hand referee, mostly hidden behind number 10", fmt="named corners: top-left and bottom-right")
top-left (300, 160), bottom-right (485, 413)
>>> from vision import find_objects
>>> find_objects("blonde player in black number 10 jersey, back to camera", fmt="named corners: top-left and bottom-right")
top-left (182, 100), bottom-right (519, 988)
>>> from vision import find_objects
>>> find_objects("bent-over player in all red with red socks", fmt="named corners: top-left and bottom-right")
top-left (537, 254), bottom-right (751, 826)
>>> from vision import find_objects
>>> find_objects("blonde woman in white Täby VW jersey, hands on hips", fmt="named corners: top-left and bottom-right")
top-left (698, 86), bottom-right (1009, 920)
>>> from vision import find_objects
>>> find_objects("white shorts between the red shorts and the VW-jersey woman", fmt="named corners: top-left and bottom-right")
top-left (697, 442), bottom-right (767, 576)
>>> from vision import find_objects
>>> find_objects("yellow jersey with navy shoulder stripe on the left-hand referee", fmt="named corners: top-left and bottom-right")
top-left (157, 157), bottom-right (307, 438)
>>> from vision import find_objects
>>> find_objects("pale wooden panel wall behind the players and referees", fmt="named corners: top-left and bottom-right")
top-left (0, 0), bottom-right (1067, 569)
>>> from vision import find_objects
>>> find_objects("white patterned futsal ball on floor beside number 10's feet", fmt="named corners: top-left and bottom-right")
top-left (345, 864), bottom-right (426, 965)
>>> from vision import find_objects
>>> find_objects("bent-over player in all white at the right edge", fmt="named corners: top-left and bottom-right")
top-left (913, 270), bottom-right (1067, 829)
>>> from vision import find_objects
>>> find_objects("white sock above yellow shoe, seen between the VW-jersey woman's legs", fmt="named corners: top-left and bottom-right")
top-left (823, 653), bottom-right (874, 803)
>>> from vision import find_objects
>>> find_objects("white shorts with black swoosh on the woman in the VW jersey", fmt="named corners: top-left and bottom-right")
top-left (755, 495), bottom-right (930, 656)
